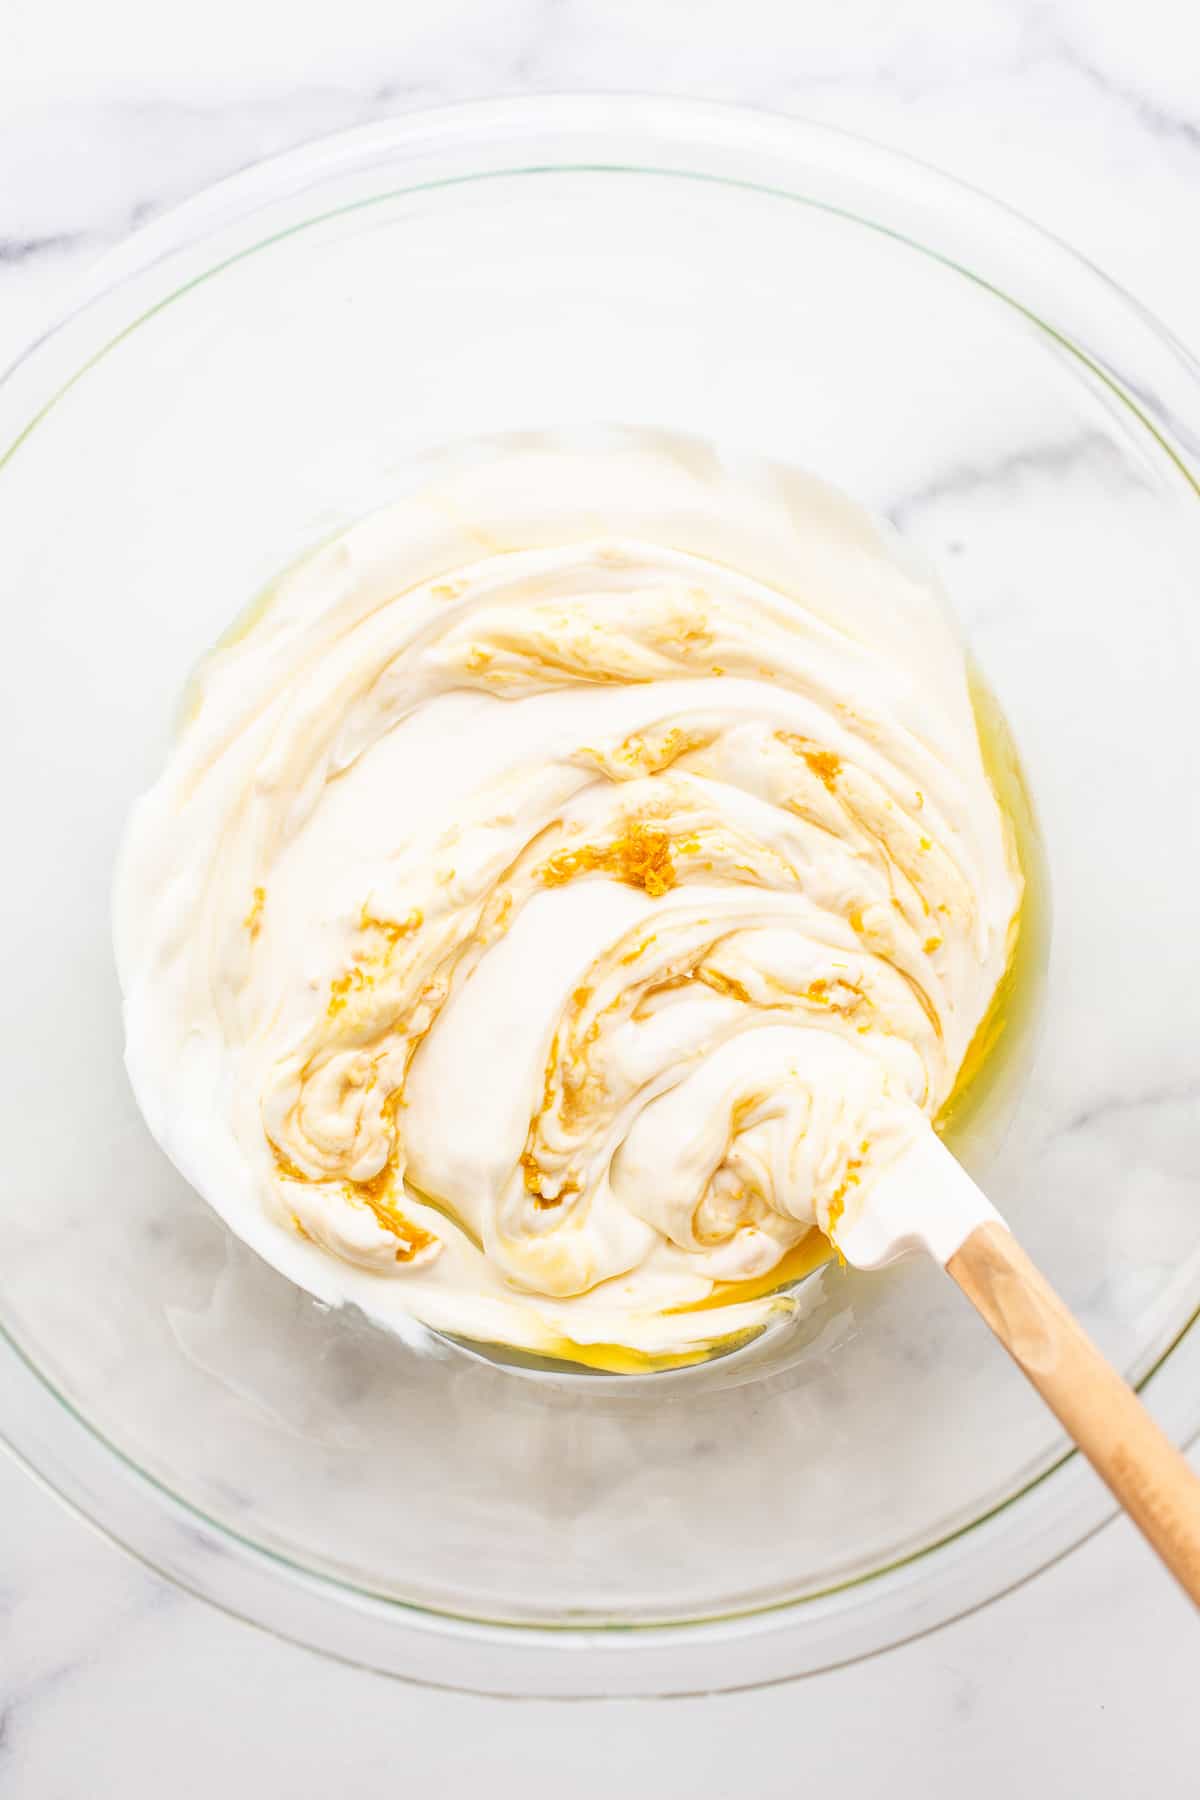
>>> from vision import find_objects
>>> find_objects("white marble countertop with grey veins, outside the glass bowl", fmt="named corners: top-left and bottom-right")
top-left (0, 0), bottom-right (1200, 1800)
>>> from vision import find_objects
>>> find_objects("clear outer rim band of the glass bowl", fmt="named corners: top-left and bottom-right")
top-left (0, 95), bottom-right (1200, 1697)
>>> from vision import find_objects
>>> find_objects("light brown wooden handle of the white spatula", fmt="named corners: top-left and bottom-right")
top-left (946, 1224), bottom-right (1200, 1606)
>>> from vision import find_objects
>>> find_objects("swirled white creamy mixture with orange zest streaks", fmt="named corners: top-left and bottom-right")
top-left (115, 436), bottom-right (1022, 1354)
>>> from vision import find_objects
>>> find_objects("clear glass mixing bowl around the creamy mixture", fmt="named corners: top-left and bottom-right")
top-left (0, 97), bottom-right (1200, 1694)
